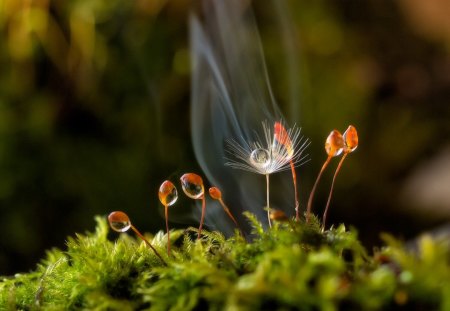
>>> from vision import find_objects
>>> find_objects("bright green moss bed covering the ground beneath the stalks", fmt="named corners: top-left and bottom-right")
top-left (0, 214), bottom-right (450, 310)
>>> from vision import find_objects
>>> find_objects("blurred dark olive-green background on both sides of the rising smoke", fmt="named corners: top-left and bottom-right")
top-left (0, 0), bottom-right (450, 275)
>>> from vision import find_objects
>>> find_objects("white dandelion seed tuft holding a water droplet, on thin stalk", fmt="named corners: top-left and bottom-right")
top-left (225, 121), bottom-right (308, 226)
